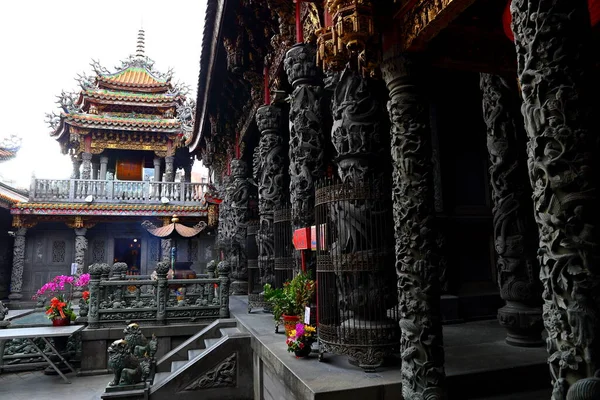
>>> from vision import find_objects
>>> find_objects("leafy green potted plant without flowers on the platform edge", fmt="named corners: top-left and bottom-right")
top-left (264, 272), bottom-right (315, 337)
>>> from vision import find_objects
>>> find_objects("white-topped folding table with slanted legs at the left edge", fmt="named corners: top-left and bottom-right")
top-left (0, 325), bottom-right (85, 383)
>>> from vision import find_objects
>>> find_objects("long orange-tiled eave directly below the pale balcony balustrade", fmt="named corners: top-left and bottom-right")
top-left (10, 203), bottom-right (208, 217)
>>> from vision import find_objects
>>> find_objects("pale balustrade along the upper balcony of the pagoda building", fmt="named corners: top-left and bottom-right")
top-left (29, 178), bottom-right (207, 204)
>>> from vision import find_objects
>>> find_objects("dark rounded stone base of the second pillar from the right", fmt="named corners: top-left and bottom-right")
top-left (498, 302), bottom-right (545, 347)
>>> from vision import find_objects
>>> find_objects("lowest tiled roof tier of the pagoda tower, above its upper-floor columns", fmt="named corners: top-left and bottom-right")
top-left (61, 113), bottom-right (181, 133)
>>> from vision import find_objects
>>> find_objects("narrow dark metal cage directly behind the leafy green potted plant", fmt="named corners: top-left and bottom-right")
top-left (273, 206), bottom-right (295, 288)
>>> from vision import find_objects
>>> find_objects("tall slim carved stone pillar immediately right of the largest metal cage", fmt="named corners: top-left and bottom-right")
top-left (382, 53), bottom-right (446, 400)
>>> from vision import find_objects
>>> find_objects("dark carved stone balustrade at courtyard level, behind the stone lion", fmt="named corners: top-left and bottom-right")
top-left (88, 268), bottom-right (229, 329)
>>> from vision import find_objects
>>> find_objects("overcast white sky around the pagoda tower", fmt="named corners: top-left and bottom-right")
top-left (0, 0), bottom-right (207, 187)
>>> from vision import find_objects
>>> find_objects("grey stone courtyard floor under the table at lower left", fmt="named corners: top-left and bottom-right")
top-left (0, 371), bottom-right (112, 400)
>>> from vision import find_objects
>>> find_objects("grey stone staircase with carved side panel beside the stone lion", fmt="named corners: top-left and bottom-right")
top-left (149, 319), bottom-right (254, 400)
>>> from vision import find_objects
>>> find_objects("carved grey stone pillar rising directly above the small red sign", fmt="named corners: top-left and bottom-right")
top-left (284, 44), bottom-right (325, 230)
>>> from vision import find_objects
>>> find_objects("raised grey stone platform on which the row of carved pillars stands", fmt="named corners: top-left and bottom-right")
top-left (230, 296), bottom-right (551, 400)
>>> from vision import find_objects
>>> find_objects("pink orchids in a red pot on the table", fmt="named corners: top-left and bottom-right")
top-left (33, 274), bottom-right (90, 319)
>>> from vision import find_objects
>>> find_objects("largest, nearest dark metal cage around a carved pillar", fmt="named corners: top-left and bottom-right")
top-left (315, 180), bottom-right (400, 371)
